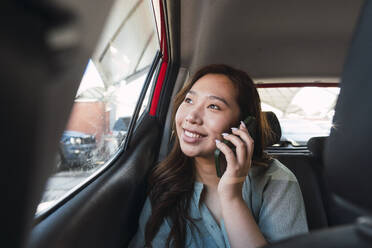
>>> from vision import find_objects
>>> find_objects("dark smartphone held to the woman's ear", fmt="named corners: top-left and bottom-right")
top-left (214, 116), bottom-right (256, 178)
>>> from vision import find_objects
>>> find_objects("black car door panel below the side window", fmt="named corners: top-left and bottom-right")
top-left (29, 116), bottom-right (161, 248)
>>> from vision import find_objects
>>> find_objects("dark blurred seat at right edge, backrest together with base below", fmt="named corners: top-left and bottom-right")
top-left (267, 1), bottom-right (372, 248)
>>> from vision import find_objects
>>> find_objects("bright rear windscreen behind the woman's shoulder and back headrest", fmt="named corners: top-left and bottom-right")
top-left (258, 87), bottom-right (340, 146)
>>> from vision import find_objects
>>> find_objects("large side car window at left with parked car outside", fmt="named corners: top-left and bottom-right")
top-left (36, 0), bottom-right (159, 215)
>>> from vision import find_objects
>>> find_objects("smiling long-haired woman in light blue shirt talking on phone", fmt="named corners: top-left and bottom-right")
top-left (130, 65), bottom-right (307, 247)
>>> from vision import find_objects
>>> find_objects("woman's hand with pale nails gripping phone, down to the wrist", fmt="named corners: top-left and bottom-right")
top-left (216, 122), bottom-right (254, 201)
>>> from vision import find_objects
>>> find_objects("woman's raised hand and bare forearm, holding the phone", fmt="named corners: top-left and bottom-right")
top-left (216, 122), bottom-right (266, 247)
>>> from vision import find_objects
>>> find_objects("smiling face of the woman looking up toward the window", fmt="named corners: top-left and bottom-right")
top-left (175, 74), bottom-right (240, 158)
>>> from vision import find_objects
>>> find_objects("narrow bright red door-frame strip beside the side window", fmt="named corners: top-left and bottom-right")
top-left (150, 0), bottom-right (168, 116)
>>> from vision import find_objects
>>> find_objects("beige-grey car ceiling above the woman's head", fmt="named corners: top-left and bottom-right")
top-left (180, 0), bottom-right (363, 82)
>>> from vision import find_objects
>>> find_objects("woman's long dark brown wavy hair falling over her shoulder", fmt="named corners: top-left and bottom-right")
top-left (145, 65), bottom-right (271, 248)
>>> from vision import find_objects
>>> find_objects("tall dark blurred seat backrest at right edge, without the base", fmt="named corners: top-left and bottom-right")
top-left (324, 1), bottom-right (372, 213)
